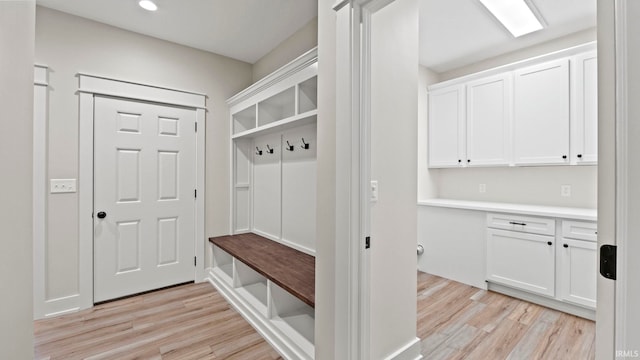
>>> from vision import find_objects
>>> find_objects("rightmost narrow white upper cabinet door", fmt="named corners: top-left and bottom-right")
top-left (572, 51), bottom-right (598, 165)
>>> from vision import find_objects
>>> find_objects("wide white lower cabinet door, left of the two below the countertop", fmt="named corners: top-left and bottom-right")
top-left (487, 229), bottom-right (555, 297)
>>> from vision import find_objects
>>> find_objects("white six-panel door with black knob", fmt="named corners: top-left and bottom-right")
top-left (94, 96), bottom-right (196, 302)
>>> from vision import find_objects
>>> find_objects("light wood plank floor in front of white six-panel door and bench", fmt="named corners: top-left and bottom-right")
top-left (34, 282), bottom-right (281, 360)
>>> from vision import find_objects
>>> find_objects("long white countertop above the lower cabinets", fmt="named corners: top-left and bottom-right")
top-left (418, 199), bottom-right (598, 221)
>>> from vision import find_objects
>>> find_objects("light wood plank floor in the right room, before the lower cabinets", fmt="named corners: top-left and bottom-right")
top-left (418, 272), bottom-right (595, 360)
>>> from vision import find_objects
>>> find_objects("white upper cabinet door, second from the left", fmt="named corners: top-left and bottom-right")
top-left (467, 74), bottom-right (512, 166)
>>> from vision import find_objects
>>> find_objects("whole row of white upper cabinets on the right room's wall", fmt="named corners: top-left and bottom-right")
top-left (428, 43), bottom-right (598, 168)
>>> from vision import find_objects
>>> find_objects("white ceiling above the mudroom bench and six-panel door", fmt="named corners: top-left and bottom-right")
top-left (37, 0), bottom-right (318, 64)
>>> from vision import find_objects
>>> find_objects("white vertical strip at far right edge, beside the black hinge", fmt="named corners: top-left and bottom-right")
top-left (612, 0), bottom-right (640, 359)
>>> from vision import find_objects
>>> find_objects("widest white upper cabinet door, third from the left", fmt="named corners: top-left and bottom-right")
top-left (514, 59), bottom-right (569, 165)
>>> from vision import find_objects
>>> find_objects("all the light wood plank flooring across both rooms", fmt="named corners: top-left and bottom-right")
top-left (35, 272), bottom-right (595, 360)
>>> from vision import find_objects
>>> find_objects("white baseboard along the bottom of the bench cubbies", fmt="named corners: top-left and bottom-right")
top-left (207, 268), bottom-right (313, 360)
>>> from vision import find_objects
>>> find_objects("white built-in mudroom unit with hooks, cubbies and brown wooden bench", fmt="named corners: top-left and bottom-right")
top-left (218, 49), bottom-right (318, 359)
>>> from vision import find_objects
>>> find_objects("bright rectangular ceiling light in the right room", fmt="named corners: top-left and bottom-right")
top-left (480, 0), bottom-right (544, 37)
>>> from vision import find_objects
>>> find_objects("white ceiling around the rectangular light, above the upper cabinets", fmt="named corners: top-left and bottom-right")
top-left (420, 0), bottom-right (596, 72)
